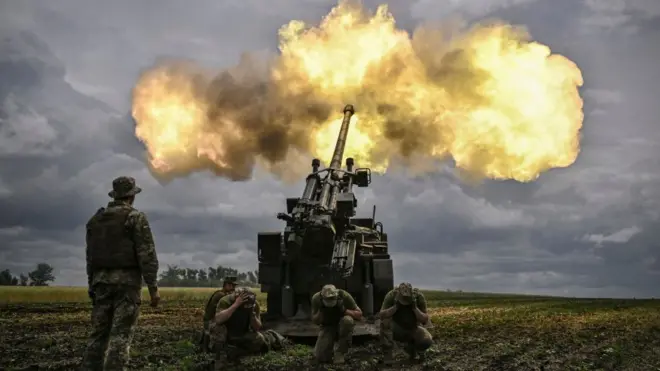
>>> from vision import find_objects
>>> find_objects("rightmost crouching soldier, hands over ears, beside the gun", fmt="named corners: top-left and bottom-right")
top-left (378, 283), bottom-right (433, 363)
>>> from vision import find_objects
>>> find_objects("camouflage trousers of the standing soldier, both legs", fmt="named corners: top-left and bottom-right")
top-left (82, 284), bottom-right (141, 371)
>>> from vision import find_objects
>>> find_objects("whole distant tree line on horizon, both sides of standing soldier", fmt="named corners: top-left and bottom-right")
top-left (0, 263), bottom-right (259, 287)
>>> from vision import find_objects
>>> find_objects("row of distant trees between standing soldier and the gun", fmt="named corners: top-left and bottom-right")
top-left (158, 265), bottom-right (259, 287)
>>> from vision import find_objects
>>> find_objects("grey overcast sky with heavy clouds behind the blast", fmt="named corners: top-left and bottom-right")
top-left (0, 0), bottom-right (660, 297)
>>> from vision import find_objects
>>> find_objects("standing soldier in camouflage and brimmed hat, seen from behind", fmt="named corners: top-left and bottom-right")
top-left (83, 177), bottom-right (158, 370)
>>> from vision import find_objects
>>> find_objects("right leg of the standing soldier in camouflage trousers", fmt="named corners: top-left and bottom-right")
top-left (105, 288), bottom-right (141, 370)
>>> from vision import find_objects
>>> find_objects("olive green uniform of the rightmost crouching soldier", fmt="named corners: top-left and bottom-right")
top-left (380, 285), bottom-right (433, 357)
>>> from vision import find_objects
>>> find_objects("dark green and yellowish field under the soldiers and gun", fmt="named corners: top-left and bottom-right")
top-left (0, 287), bottom-right (660, 371)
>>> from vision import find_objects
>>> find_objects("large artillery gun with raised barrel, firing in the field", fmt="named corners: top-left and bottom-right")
top-left (257, 105), bottom-right (394, 337)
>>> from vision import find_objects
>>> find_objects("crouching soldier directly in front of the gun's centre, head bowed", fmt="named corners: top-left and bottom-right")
top-left (312, 285), bottom-right (362, 364)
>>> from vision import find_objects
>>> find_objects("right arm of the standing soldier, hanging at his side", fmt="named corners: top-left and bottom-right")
top-left (132, 212), bottom-right (158, 293)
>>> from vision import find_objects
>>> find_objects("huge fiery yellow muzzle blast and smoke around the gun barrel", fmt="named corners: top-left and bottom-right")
top-left (133, 1), bottom-right (583, 182)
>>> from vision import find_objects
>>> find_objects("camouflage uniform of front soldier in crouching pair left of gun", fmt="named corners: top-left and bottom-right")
top-left (209, 288), bottom-right (274, 370)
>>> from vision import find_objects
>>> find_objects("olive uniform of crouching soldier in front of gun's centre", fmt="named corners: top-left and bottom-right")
top-left (311, 289), bottom-right (358, 362)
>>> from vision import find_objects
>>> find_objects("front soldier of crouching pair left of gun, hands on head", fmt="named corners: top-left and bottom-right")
top-left (209, 288), bottom-right (284, 370)
